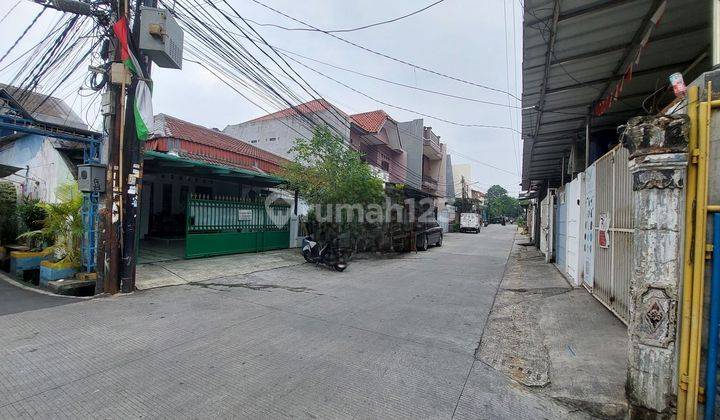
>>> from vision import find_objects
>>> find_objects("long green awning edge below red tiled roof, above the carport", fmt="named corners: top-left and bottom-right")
top-left (144, 151), bottom-right (283, 187)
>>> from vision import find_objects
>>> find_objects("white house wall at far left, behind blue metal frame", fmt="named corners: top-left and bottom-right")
top-left (0, 134), bottom-right (76, 202)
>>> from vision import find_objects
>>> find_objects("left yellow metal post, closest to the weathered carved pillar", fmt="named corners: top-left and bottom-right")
top-left (677, 86), bottom-right (699, 420)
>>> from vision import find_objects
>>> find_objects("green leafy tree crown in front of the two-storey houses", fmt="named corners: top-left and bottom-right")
top-left (283, 126), bottom-right (384, 205)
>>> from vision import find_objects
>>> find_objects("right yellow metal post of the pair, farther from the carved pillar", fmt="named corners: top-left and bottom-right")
top-left (685, 82), bottom-right (712, 419)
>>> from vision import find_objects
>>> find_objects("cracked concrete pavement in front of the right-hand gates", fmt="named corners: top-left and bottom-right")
top-left (476, 235), bottom-right (627, 418)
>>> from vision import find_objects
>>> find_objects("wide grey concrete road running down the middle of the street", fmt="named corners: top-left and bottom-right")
top-left (0, 225), bottom-right (584, 419)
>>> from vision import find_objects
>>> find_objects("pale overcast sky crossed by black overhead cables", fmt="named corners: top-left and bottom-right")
top-left (0, 0), bottom-right (522, 193)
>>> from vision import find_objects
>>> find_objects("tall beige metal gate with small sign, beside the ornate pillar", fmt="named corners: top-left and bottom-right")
top-left (592, 146), bottom-right (634, 323)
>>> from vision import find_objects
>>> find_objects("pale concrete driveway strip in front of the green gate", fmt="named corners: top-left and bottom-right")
top-left (135, 248), bottom-right (305, 290)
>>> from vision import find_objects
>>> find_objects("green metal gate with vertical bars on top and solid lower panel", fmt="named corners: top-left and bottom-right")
top-left (185, 196), bottom-right (290, 258)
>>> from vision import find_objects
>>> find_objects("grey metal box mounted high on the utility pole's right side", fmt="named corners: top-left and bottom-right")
top-left (140, 7), bottom-right (184, 69)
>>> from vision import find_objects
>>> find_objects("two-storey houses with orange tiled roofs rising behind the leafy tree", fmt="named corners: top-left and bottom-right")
top-left (223, 100), bottom-right (456, 212)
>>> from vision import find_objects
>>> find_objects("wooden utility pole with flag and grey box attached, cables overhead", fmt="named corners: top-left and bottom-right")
top-left (34, 0), bottom-right (183, 294)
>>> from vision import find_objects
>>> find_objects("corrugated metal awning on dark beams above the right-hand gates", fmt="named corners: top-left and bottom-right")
top-left (522, 0), bottom-right (711, 190)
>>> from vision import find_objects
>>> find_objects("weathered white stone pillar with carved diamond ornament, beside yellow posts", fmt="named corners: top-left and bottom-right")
top-left (625, 116), bottom-right (688, 418)
